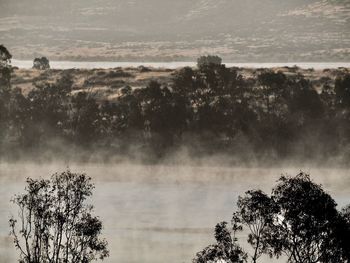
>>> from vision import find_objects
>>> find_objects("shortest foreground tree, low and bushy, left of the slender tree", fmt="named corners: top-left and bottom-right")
top-left (192, 222), bottom-right (247, 263)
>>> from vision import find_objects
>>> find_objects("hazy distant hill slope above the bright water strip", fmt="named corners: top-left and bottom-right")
top-left (0, 0), bottom-right (350, 61)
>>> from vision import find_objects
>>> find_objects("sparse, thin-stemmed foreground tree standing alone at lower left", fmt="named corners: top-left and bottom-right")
top-left (9, 171), bottom-right (108, 263)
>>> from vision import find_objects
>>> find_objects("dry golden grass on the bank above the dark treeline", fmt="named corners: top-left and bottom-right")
top-left (12, 67), bottom-right (349, 100)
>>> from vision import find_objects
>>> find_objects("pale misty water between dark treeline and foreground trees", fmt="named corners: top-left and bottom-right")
top-left (0, 162), bottom-right (350, 263)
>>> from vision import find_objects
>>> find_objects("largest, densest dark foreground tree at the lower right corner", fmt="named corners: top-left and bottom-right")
top-left (269, 173), bottom-right (348, 263)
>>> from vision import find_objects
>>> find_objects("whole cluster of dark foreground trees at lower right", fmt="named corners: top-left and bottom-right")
top-left (193, 172), bottom-right (350, 263)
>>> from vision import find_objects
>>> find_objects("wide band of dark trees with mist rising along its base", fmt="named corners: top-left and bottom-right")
top-left (0, 47), bottom-right (350, 163)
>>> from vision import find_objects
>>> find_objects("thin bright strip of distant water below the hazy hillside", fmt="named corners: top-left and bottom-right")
top-left (12, 59), bottom-right (350, 69)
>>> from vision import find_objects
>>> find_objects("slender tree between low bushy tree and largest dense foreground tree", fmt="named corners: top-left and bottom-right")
top-left (232, 190), bottom-right (278, 263)
